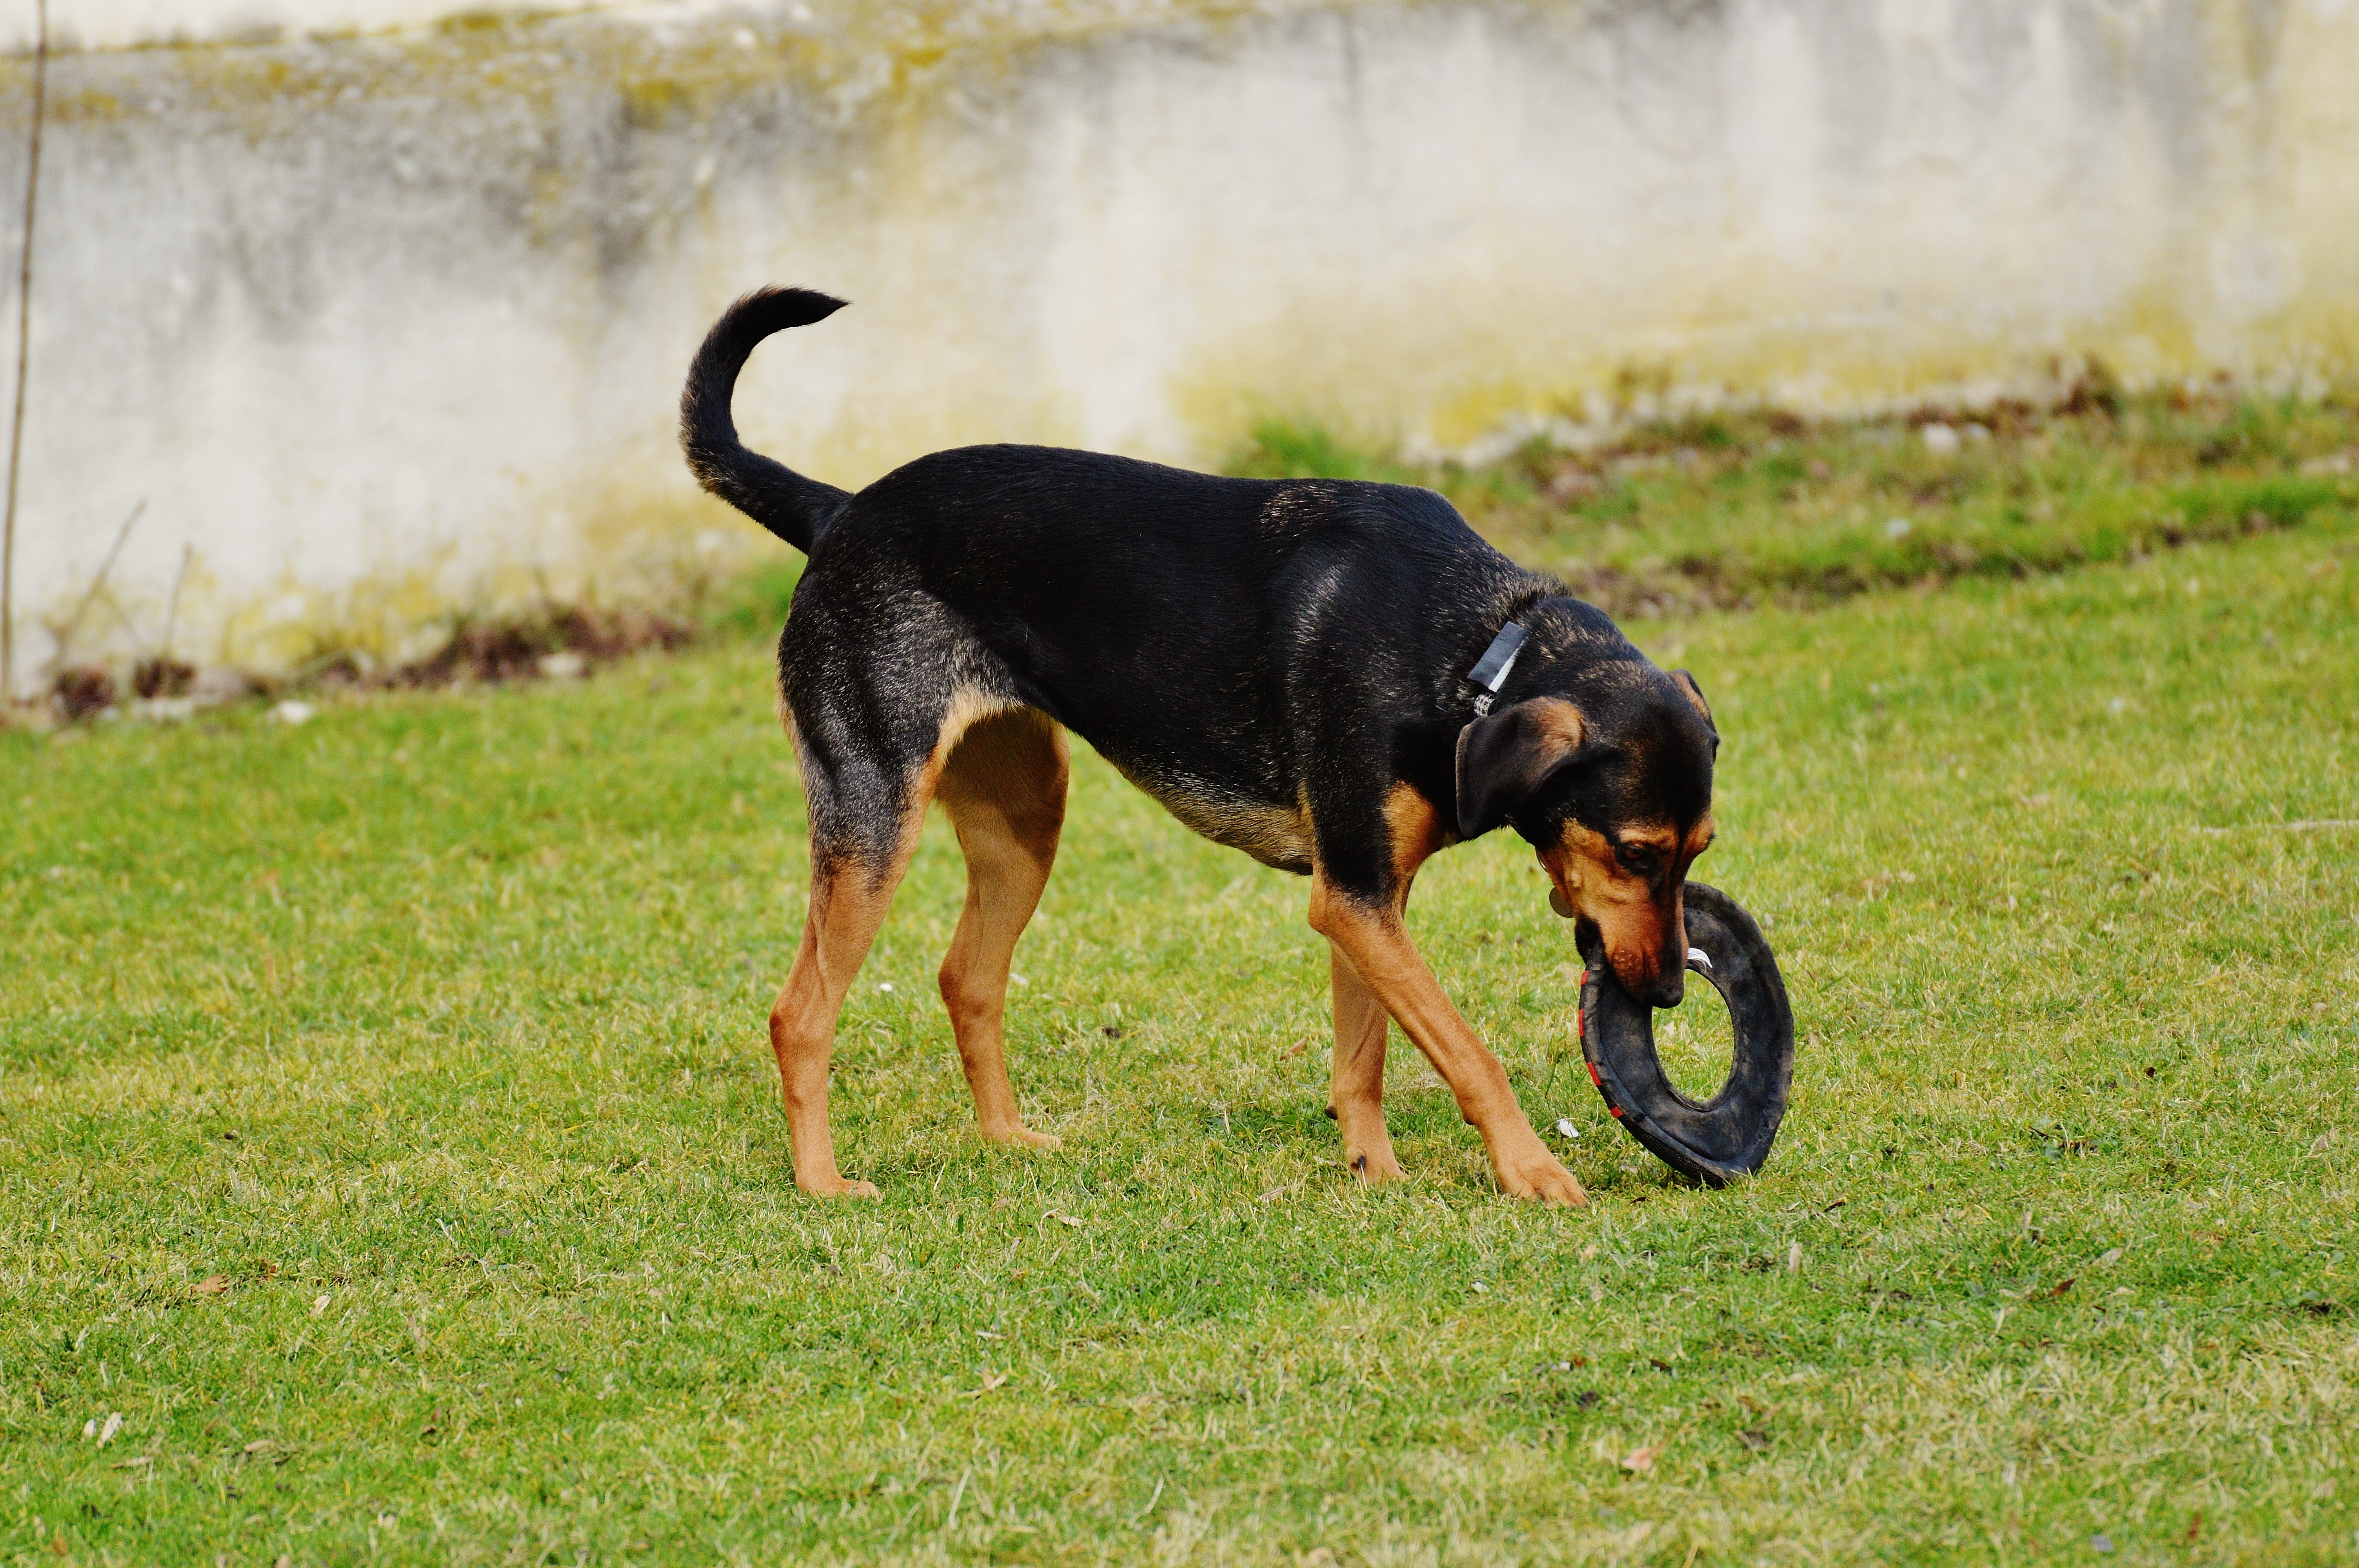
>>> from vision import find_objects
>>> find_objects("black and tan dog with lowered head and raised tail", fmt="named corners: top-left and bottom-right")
top-left (680, 290), bottom-right (1717, 1203)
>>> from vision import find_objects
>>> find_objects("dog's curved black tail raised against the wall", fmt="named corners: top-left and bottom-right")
top-left (680, 288), bottom-right (852, 554)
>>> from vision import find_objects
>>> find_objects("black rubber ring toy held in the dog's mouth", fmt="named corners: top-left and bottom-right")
top-left (1581, 882), bottom-right (1793, 1186)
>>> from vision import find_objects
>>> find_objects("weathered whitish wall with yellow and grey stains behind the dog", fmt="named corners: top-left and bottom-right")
top-left (0, 0), bottom-right (2359, 672)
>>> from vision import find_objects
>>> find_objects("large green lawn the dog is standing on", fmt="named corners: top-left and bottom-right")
top-left (0, 493), bottom-right (2359, 1568)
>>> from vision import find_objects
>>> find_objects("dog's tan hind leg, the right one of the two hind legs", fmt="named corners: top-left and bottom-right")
top-left (934, 710), bottom-right (1069, 1148)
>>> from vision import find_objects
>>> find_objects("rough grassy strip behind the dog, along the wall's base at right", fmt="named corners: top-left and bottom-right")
top-left (1229, 391), bottom-right (2359, 615)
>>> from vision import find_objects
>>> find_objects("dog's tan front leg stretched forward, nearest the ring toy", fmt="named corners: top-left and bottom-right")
top-left (1312, 870), bottom-right (1590, 1205)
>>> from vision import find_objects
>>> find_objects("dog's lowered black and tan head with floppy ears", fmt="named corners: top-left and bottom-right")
top-left (1458, 644), bottom-right (1720, 1007)
